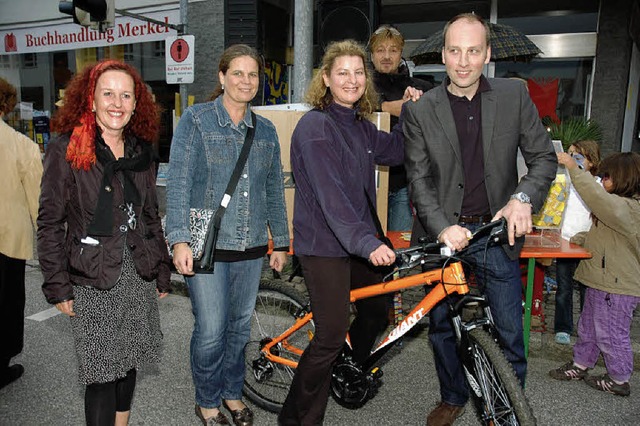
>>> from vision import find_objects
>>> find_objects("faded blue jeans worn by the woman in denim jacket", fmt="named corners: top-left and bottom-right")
top-left (186, 258), bottom-right (263, 408)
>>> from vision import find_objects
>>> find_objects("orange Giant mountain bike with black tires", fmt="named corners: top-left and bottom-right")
top-left (244, 220), bottom-right (536, 425)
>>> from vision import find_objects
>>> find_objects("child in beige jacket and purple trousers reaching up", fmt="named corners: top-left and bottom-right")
top-left (549, 152), bottom-right (640, 396)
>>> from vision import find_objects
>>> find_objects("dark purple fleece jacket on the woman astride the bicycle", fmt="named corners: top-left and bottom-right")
top-left (291, 103), bottom-right (404, 258)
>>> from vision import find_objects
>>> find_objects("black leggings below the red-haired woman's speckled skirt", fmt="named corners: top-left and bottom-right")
top-left (84, 368), bottom-right (136, 426)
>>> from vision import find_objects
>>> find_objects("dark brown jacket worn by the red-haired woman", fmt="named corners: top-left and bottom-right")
top-left (38, 135), bottom-right (171, 304)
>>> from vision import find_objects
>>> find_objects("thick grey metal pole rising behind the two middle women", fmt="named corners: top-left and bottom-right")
top-left (292, 0), bottom-right (313, 102)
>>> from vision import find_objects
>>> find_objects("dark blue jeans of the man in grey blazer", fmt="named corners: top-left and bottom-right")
top-left (429, 225), bottom-right (527, 406)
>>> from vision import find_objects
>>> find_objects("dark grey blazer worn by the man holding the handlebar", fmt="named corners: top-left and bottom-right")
top-left (403, 79), bottom-right (558, 251)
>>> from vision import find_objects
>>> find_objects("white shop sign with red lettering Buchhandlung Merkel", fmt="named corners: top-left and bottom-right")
top-left (0, 9), bottom-right (180, 55)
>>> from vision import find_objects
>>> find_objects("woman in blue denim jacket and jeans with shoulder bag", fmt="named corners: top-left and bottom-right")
top-left (166, 45), bottom-right (289, 426)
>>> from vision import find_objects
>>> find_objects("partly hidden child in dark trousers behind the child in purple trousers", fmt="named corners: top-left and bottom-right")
top-left (554, 140), bottom-right (600, 345)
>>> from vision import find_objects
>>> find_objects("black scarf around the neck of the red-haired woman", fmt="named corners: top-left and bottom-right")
top-left (87, 132), bottom-right (153, 236)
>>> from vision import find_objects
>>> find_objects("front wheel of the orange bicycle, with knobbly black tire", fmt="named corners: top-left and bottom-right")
top-left (463, 328), bottom-right (536, 426)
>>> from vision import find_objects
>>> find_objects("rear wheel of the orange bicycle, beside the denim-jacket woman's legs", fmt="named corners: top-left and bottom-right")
top-left (243, 281), bottom-right (315, 413)
